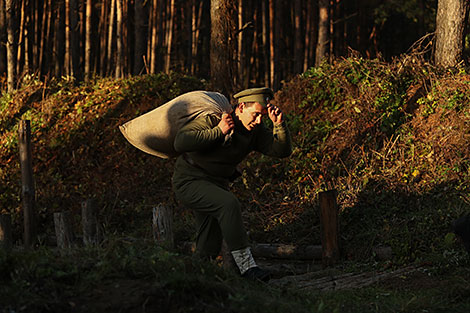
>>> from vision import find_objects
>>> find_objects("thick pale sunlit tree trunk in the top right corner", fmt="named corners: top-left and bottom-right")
top-left (434, 0), bottom-right (469, 67)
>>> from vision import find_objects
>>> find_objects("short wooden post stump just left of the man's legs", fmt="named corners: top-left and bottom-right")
top-left (152, 204), bottom-right (174, 248)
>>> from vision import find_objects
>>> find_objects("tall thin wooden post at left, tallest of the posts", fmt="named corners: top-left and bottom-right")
top-left (18, 120), bottom-right (36, 247)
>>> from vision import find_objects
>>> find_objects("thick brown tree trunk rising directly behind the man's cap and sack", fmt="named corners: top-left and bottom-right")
top-left (210, 0), bottom-right (233, 95)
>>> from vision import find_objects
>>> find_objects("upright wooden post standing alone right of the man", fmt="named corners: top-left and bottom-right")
top-left (319, 189), bottom-right (339, 266)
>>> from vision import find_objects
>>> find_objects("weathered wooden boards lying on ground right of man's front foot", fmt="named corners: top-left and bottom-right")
top-left (269, 266), bottom-right (418, 291)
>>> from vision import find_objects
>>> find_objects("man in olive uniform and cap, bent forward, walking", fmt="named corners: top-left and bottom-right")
top-left (172, 87), bottom-right (292, 281)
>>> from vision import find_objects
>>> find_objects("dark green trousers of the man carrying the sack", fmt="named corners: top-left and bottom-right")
top-left (173, 169), bottom-right (248, 258)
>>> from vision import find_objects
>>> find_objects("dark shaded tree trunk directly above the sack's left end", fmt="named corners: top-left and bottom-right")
top-left (133, 0), bottom-right (147, 75)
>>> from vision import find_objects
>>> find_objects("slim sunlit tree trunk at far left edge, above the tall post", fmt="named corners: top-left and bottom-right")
top-left (5, 0), bottom-right (16, 92)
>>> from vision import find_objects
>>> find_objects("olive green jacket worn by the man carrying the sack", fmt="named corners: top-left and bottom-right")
top-left (174, 115), bottom-right (292, 179)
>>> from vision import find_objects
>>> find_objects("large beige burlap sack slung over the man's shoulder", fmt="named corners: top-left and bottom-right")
top-left (119, 91), bottom-right (232, 159)
